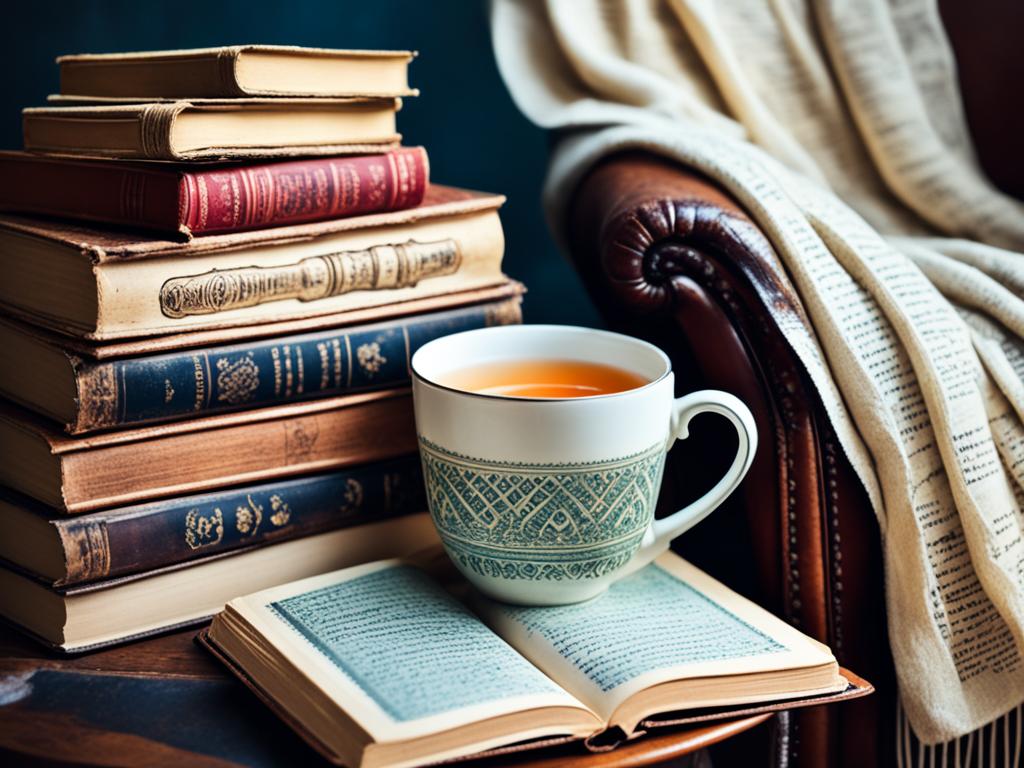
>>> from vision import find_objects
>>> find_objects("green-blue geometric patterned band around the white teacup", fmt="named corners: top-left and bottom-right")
top-left (420, 437), bottom-right (665, 582)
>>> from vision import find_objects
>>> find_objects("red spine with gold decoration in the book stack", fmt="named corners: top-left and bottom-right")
top-left (180, 146), bottom-right (429, 234)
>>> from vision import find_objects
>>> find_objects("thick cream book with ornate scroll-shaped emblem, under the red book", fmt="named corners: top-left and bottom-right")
top-left (0, 184), bottom-right (506, 339)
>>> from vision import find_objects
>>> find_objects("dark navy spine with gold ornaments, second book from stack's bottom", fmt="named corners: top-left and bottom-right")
top-left (53, 456), bottom-right (426, 586)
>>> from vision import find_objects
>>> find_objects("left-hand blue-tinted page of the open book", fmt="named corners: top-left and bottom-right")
top-left (227, 560), bottom-right (583, 742)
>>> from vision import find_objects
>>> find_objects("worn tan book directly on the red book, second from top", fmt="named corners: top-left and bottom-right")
top-left (22, 98), bottom-right (401, 161)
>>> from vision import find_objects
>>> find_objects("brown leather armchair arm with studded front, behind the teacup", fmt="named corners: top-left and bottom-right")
top-left (568, 154), bottom-right (895, 768)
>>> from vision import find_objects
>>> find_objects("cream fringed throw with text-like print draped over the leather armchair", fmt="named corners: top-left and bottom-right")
top-left (492, 0), bottom-right (1024, 743)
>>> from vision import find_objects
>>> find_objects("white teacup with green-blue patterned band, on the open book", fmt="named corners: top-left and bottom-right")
top-left (412, 326), bottom-right (757, 605)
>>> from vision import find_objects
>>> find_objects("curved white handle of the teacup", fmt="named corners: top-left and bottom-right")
top-left (622, 389), bottom-right (758, 575)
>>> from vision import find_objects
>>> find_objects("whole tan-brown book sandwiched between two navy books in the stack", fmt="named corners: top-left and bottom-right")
top-left (0, 391), bottom-right (417, 513)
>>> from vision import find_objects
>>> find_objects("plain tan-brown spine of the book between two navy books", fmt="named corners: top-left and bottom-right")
top-left (58, 389), bottom-right (417, 515)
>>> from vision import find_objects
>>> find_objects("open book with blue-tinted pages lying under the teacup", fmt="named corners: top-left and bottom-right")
top-left (203, 553), bottom-right (863, 766)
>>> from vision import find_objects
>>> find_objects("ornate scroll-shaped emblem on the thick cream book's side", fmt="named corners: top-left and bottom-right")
top-left (160, 240), bottom-right (462, 317)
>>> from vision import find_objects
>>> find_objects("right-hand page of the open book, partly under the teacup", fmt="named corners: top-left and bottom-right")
top-left (476, 552), bottom-right (831, 720)
